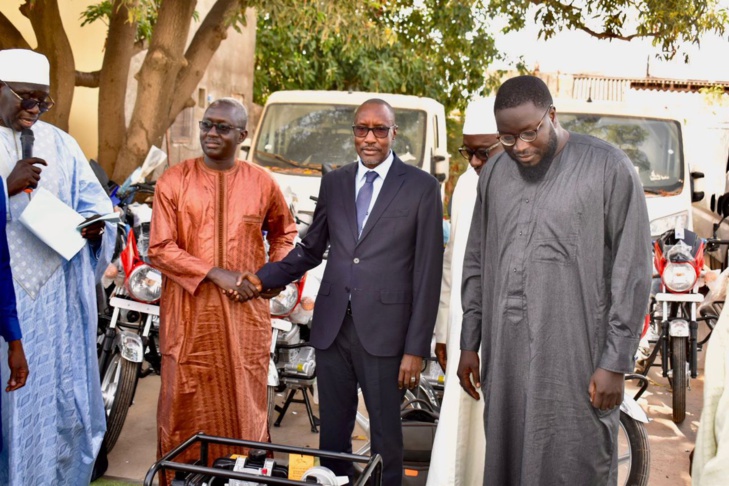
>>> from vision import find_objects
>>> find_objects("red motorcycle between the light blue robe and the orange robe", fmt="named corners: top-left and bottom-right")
top-left (98, 190), bottom-right (162, 452)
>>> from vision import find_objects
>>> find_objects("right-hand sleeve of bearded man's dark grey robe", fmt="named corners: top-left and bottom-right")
top-left (598, 153), bottom-right (651, 373)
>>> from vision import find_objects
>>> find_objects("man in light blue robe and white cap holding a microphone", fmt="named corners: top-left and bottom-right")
top-left (0, 49), bottom-right (115, 486)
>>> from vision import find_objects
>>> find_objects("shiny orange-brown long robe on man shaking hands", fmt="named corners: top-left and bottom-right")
top-left (149, 158), bottom-right (296, 468)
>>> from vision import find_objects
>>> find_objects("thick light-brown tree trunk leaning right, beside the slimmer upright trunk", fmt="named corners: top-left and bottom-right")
top-left (111, 0), bottom-right (196, 181)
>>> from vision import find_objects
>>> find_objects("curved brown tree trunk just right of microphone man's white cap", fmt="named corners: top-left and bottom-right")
top-left (20, 0), bottom-right (76, 131)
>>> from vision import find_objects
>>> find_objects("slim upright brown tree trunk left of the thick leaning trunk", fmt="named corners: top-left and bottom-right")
top-left (97, 0), bottom-right (139, 178)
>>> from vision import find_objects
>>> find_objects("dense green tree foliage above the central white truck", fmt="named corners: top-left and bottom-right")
top-left (254, 0), bottom-right (497, 114)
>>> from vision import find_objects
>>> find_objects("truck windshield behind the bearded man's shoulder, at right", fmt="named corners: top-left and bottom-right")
top-left (558, 113), bottom-right (685, 196)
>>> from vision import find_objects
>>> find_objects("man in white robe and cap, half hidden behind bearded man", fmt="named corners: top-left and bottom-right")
top-left (427, 98), bottom-right (503, 486)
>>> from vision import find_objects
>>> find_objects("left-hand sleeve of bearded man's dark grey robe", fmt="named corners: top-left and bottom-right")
top-left (461, 171), bottom-right (487, 351)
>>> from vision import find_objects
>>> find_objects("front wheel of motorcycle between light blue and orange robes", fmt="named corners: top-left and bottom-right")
top-left (101, 353), bottom-right (140, 452)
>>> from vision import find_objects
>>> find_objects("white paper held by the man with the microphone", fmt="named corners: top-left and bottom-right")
top-left (18, 187), bottom-right (86, 260)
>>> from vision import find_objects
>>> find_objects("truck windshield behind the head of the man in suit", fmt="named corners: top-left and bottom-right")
top-left (250, 103), bottom-right (426, 175)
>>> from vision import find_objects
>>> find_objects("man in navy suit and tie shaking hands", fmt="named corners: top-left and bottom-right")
top-left (245, 99), bottom-right (443, 485)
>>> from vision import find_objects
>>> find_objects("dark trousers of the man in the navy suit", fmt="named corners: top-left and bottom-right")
top-left (316, 315), bottom-right (405, 486)
